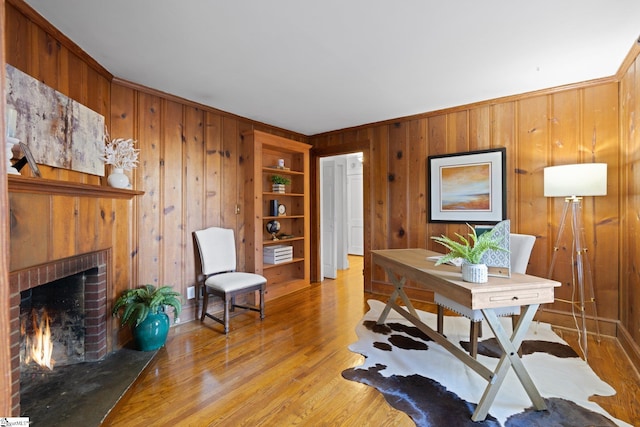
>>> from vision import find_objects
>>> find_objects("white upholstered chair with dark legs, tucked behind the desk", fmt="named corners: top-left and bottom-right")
top-left (434, 233), bottom-right (536, 358)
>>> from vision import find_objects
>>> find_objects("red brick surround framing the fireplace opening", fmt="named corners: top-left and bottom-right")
top-left (9, 249), bottom-right (111, 414)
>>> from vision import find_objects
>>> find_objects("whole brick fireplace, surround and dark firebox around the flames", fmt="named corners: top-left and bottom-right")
top-left (9, 249), bottom-right (111, 414)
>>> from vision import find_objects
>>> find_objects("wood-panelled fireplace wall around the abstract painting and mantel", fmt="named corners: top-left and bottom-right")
top-left (3, 2), bottom-right (125, 348)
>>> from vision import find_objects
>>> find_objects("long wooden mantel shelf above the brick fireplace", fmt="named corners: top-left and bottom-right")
top-left (7, 175), bottom-right (144, 199)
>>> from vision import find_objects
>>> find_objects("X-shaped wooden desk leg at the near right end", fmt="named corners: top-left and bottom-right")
top-left (471, 304), bottom-right (547, 421)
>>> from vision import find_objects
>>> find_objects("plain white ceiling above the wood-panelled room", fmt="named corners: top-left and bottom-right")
top-left (26, 0), bottom-right (640, 135)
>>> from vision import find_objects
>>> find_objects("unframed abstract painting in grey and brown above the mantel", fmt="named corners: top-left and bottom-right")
top-left (6, 64), bottom-right (104, 176)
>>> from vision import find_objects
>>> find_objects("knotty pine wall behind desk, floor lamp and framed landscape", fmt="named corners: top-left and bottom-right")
top-left (310, 79), bottom-right (621, 335)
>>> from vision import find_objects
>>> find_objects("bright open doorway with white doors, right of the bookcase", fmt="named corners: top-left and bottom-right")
top-left (320, 152), bottom-right (364, 280)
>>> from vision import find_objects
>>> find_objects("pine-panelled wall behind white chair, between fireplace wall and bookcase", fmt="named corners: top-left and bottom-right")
top-left (111, 81), bottom-right (305, 328)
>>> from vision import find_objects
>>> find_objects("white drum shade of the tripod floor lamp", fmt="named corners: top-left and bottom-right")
top-left (544, 163), bottom-right (607, 197)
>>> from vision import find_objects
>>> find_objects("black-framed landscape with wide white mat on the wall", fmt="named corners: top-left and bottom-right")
top-left (427, 148), bottom-right (507, 224)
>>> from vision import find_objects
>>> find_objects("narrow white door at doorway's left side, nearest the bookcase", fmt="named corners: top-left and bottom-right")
top-left (320, 158), bottom-right (338, 279)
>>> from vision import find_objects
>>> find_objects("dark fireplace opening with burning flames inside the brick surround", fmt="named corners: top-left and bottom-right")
top-left (20, 269), bottom-right (89, 373)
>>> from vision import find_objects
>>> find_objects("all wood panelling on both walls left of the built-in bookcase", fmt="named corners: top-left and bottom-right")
top-left (4, 0), bottom-right (306, 356)
